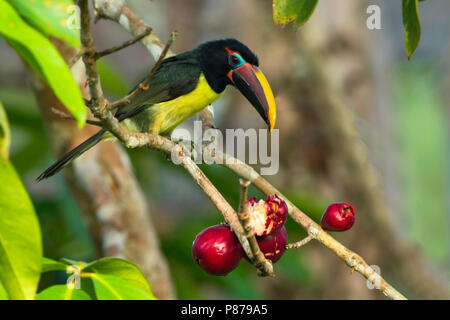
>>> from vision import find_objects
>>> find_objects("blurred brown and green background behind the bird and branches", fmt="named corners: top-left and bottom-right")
top-left (0, 0), bottom-right (450, 299)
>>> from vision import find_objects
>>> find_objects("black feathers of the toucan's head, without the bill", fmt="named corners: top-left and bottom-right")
top-left (198, 39), bottom-right (259, 93)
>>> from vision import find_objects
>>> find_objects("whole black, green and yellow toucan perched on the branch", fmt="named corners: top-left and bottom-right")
top-left (37, 39), bottom-right (276, 181)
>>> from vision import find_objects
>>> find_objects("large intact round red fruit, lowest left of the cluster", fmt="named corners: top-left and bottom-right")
top-left (192, 225), bottom-right (244, 276)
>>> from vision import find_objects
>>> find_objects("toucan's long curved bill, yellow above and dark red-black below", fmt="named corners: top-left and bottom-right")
top-left (228, 63), bottom-right (277, 131)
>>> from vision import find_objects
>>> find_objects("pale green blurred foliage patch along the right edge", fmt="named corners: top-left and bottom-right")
top-left (392, 62), bottom-right (450, 265)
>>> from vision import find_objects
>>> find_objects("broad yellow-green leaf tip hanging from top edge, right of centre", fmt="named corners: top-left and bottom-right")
top-left (273, 0), bottom-right (319, 27)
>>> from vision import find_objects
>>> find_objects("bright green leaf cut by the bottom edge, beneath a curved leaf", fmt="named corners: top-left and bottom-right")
top-left (85, 273), bottom-right (155, 300)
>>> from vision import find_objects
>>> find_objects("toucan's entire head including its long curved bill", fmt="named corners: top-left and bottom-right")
top-left (197, 39), bottom-right (276, 130)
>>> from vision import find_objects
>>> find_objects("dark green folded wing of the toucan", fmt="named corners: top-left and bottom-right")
top-left (115, 51), bottom-right (201, 120)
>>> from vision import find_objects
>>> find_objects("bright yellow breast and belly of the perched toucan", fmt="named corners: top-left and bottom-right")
top-left (149, 74), bottom-right (221, 134)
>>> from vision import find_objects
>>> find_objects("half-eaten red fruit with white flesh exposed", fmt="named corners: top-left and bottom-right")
top-left (247, 195), bottom-right (288, 236)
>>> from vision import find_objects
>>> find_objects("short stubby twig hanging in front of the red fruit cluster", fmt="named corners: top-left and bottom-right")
top-left (238, 179), bottom-right (275, 277)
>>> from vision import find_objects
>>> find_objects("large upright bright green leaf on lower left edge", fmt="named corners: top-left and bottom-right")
top-left (0, 162), bottom-right (42, 299)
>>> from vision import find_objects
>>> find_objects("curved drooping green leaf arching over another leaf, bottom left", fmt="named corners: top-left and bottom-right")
top-left (83, 258), bottom-right (153, 296)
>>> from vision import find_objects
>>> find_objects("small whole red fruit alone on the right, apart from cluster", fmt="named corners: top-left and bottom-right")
top-left (320, 202), bottom-right (355, 231)
